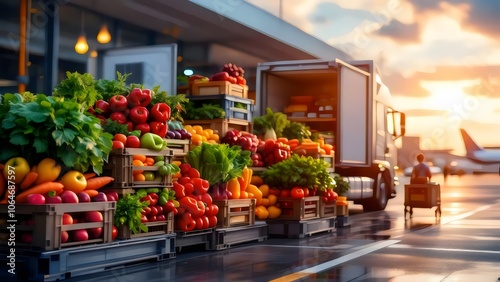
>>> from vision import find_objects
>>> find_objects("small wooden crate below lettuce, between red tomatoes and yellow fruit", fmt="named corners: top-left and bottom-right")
top-left (213, 199), bottom-right (256, 228)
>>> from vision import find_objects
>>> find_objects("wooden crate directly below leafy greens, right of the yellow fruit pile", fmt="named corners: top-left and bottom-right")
top-left (276, 196), bottom-right (320, 220)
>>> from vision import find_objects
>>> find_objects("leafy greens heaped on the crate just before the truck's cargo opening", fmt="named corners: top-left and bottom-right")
top-left (262, 154), bottom-right (335, 191)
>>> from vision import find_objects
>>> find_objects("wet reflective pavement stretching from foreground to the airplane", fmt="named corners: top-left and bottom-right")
top-left (6, 175), bottom-right (500, 282)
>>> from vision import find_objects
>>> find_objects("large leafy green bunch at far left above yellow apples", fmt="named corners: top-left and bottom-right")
top-left (0, 94), bottom-right (113, 174)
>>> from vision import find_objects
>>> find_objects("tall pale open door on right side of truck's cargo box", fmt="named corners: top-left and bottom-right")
top-left (335, 59), bottom-right (372, 167)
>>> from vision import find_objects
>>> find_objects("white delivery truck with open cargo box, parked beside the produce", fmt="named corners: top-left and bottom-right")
top-left (254, 59), bottom-right (405, 211)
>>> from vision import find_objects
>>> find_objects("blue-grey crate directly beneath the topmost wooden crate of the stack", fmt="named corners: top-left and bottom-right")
top-left (188, 94), bottom-right (254, 122)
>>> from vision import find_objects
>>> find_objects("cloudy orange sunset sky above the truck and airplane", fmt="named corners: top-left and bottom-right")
top-left (248, 0), bottom-right (500, 155)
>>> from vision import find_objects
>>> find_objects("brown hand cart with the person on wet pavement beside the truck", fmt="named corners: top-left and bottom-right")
top-left (404, 182), bottom-right (441, 219)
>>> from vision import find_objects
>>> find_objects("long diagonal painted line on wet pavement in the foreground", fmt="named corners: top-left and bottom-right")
top-left (270, 240), bottom-right (400, 282)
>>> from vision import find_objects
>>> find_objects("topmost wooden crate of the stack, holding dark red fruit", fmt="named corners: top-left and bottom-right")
top-left (190, 81), bottom-right (248, 98)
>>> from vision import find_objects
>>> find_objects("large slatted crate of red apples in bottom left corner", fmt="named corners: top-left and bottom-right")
top-left (0, 201), bottom-right (116, 251)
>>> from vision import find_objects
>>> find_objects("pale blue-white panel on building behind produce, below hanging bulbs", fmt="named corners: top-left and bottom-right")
top-left (92, 44), bottom-right (177, 95)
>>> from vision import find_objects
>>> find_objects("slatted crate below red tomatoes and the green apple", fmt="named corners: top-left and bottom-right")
top-left (103, 148), bottom-right (174, 188)
